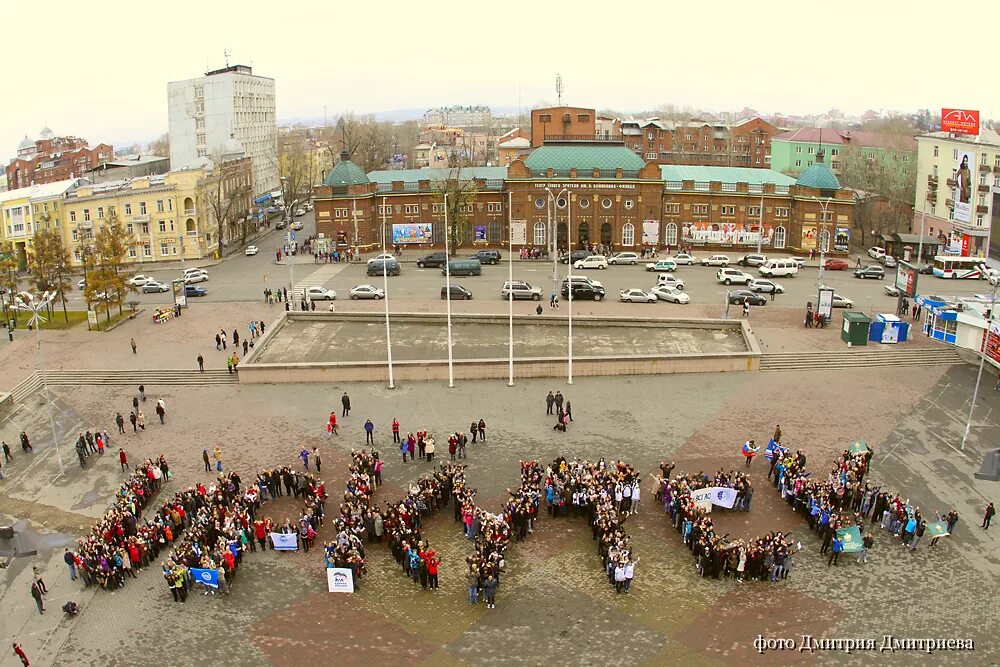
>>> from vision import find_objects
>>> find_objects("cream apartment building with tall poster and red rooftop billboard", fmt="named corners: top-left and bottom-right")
top-left (910, 128), bottom-right (1000, 257)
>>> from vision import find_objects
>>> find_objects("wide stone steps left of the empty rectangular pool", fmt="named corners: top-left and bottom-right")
top-left (11, 369), bottom-right (239, 403)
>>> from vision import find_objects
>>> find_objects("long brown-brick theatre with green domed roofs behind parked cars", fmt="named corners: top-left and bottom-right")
top-left (314, 141), bottom-right (855, 254)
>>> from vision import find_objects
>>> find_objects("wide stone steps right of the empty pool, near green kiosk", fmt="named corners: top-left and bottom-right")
top-left (760, 347), bottom-right (964, 371)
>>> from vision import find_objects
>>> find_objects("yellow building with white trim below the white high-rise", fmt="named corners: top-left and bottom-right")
top-left (61, 157), bottom-right (253, 265)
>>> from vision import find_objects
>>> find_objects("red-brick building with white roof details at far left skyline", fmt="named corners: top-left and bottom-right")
top-left (4, 127), bottom-right (115, 190)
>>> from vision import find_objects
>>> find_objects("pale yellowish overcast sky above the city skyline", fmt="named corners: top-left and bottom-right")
top-left (0, 0), bottom-right (1000, 162)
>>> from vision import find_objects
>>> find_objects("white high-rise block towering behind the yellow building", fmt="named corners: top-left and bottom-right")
top-left (167, 65), bottom-right (278, 195)
